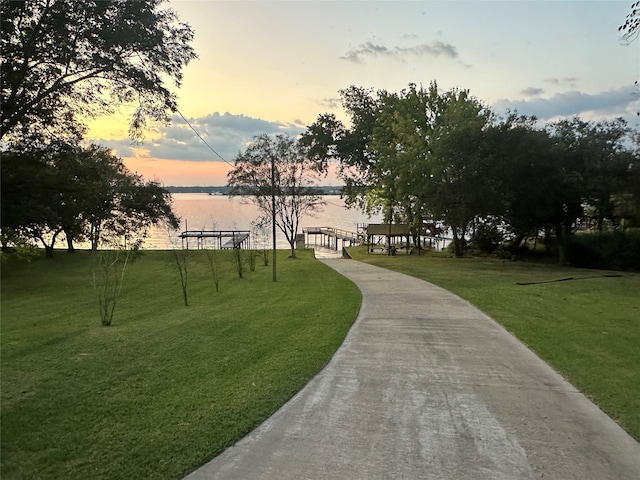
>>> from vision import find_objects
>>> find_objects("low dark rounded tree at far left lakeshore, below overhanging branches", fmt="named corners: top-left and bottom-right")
top-left (1, 144), bottom-right (179, 255)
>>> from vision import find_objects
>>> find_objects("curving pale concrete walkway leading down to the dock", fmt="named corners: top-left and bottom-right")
top-left (187, 259), bottom-right (640, 480)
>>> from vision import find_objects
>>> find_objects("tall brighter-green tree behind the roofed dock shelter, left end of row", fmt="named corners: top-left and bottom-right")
top-left (302, 82), bottom-right (490, 254)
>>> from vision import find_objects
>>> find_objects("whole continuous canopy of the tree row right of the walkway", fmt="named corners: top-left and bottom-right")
top-left (301, 82), bottom-right (640, 262)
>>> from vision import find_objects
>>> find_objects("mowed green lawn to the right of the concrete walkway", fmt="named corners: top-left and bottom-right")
top-left (350, 248), bottom-right (640, 440)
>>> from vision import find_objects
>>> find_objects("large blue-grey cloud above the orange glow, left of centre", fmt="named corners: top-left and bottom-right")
top-left (92, 112), bottom-right (305, 162)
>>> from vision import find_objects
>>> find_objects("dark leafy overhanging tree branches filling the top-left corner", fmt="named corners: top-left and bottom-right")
top-left (0, 0), bottom-right (196, 140)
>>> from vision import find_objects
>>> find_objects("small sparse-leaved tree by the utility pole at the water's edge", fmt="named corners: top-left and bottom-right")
top-left (228, 135), bottom-right (324, 258)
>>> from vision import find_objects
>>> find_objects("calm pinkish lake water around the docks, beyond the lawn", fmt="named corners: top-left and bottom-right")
top-left (144, 193), bottom-right (381, 250)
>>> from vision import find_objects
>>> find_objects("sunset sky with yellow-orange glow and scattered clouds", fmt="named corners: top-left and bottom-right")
top-left (87, 0), bottom-right (640, 186)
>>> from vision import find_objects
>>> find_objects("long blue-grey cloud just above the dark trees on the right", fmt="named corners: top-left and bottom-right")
top-left (493, 87), bottom-right (640, 120)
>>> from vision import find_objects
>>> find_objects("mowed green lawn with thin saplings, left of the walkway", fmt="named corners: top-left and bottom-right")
top-left (0, 251), bottom-right (361, 480)
